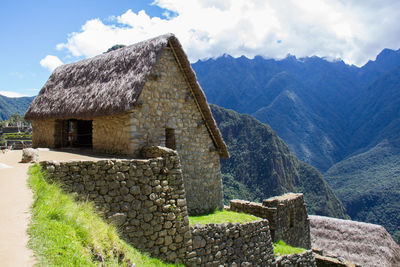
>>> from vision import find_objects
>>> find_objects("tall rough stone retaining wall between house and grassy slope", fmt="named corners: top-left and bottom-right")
top-left (40, 148), bottom-right (192, 262)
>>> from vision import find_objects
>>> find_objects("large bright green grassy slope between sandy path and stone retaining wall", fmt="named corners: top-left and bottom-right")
top-left (28, 164), bottom-right (175, 266)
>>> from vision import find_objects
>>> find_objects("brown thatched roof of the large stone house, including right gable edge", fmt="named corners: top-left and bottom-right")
top-left (25, 34), bottom-right (229, 157)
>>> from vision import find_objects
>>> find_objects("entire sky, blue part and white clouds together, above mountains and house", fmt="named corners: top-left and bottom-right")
top-left (0, 0), bottom-right (400, 96)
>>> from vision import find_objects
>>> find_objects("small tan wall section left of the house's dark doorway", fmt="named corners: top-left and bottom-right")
top-left (32, 120), bottom-right (56, 148)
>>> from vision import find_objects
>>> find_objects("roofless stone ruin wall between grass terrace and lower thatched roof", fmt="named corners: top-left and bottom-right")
top-left (230, 193), bottom-right (311, 249)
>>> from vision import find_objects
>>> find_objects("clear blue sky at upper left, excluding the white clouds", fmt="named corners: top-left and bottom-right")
top-left (0, 0), bottom-right (162, 95)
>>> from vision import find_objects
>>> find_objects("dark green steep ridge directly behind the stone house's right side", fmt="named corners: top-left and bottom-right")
top-left (211, 105), bottom-right (346, 218)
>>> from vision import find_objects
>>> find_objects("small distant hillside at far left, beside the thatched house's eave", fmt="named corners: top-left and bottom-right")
top-left (0, 95), bottom-right (35, 120)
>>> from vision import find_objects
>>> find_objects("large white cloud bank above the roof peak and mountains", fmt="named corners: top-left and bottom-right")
top-left (57, 0), bottom-right (400, 65)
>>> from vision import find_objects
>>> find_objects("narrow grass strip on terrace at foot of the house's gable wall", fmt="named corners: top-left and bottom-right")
top-left (189, 210), bottom-right (260, 225)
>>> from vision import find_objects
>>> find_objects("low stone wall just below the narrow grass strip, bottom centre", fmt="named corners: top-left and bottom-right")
top-left (187, 220), bottom-right (275, 266)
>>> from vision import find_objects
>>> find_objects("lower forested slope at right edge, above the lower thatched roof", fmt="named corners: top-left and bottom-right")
top-left (325, 138), bottom-right (400, 236)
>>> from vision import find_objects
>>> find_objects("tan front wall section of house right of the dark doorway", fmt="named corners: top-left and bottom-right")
top-left (92, 113), bottom-right (131, 155)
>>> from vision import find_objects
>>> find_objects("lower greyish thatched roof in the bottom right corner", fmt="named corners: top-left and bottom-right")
top-left (309, 216), bottom-right (400, 266)
